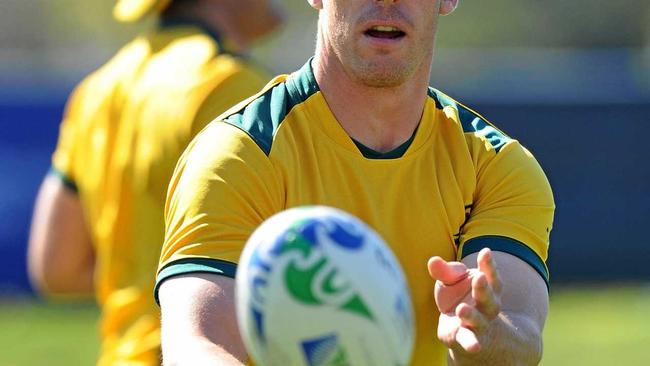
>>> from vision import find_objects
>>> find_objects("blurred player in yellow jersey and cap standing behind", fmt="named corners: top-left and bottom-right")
top-left (29, 0), bottom-right (282, 365)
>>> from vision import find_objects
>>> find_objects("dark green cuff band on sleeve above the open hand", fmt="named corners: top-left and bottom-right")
top-left (461, 236), bottom-right (550, 288)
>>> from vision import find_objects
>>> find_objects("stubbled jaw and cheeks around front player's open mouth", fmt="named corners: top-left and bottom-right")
top-left (322, 0), bottom-right (436, 88)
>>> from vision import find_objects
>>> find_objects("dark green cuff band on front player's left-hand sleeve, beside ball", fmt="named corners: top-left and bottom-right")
top-left (153, 258), bottom-right (237, 305)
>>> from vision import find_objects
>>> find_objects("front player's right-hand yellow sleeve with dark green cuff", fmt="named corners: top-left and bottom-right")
top-left (458, 138), bottom-right (555, 286)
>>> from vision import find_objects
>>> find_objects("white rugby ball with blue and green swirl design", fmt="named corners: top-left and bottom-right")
top-left (236, 206), bottom-right (414, 366)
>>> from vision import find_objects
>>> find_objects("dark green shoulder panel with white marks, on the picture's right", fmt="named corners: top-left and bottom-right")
top-left (428, 87), bottom-right (512, 152)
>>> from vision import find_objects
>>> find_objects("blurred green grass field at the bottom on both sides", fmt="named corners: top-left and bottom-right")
top-left (0, 285), bottom-right (650, 366)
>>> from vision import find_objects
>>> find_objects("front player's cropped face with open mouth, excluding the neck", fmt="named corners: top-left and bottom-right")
top-left (320, 0), bottom-right (440, 87)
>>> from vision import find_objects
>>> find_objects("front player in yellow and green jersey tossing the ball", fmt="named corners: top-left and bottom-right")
top-left (155, 0), bottom-right (555, 366)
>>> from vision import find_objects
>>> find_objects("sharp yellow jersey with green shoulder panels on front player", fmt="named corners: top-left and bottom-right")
top-left (157, 62), bottom-right (554, 365)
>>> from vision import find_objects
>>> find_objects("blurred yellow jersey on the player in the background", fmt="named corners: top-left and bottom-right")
top-left (52, 23), bottom-right (268, 365)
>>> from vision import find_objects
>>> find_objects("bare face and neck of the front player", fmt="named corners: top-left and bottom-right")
top-left (309, 0), bottom-right (457, 152)
